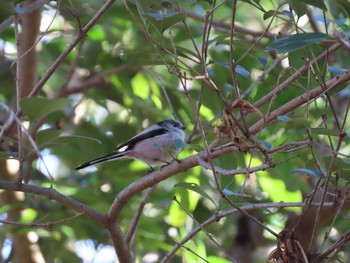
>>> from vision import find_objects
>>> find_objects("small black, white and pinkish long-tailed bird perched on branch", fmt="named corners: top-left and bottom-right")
top-left (75, 120), bottom-right (185, 170)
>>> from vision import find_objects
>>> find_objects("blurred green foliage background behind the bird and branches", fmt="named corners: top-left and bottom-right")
top-left (0, 0), bottom-right (350, 263)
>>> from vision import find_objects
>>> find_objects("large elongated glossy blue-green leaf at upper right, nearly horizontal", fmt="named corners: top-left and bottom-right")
top-left (266, 33), bottom-right (328, 53)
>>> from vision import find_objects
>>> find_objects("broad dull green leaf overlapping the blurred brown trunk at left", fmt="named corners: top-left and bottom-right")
top-left (19, 97), bottom-right (69, 121)
